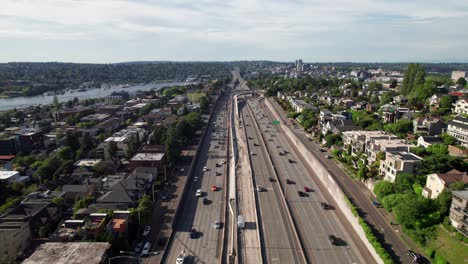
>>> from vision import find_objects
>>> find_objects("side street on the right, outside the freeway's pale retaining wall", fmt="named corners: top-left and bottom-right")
top-left (269, 100), bottom-right (412, 263)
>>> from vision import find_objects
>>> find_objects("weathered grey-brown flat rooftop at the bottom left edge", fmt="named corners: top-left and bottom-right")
top-left (23, 242), bottom-right (111, 264)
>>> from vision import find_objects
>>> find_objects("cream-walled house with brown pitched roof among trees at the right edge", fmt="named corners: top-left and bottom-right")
top-left (422, 170), bottom-right (468, 199)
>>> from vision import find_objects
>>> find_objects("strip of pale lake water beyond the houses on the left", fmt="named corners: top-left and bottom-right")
top-left (0, 82), bottom-right (190, 111)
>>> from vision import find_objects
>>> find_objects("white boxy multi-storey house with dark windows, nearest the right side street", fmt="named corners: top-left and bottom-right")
top-left (379, 152), bottom-right (422, 182)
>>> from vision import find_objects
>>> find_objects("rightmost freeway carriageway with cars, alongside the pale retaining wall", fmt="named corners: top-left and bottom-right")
top-left (249, 100), bottom-right (373, 263)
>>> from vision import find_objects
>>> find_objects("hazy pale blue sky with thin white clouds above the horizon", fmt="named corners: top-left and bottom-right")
top-left (0, 0), bottom-right (468, 63)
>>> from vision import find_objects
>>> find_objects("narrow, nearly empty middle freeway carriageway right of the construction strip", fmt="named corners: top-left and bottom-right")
top-left (239, 101), bottom-right (302, 263)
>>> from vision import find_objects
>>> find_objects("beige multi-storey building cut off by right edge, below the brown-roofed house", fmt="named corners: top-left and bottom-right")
top-left (449, 190), bottom-right (468, 236)
